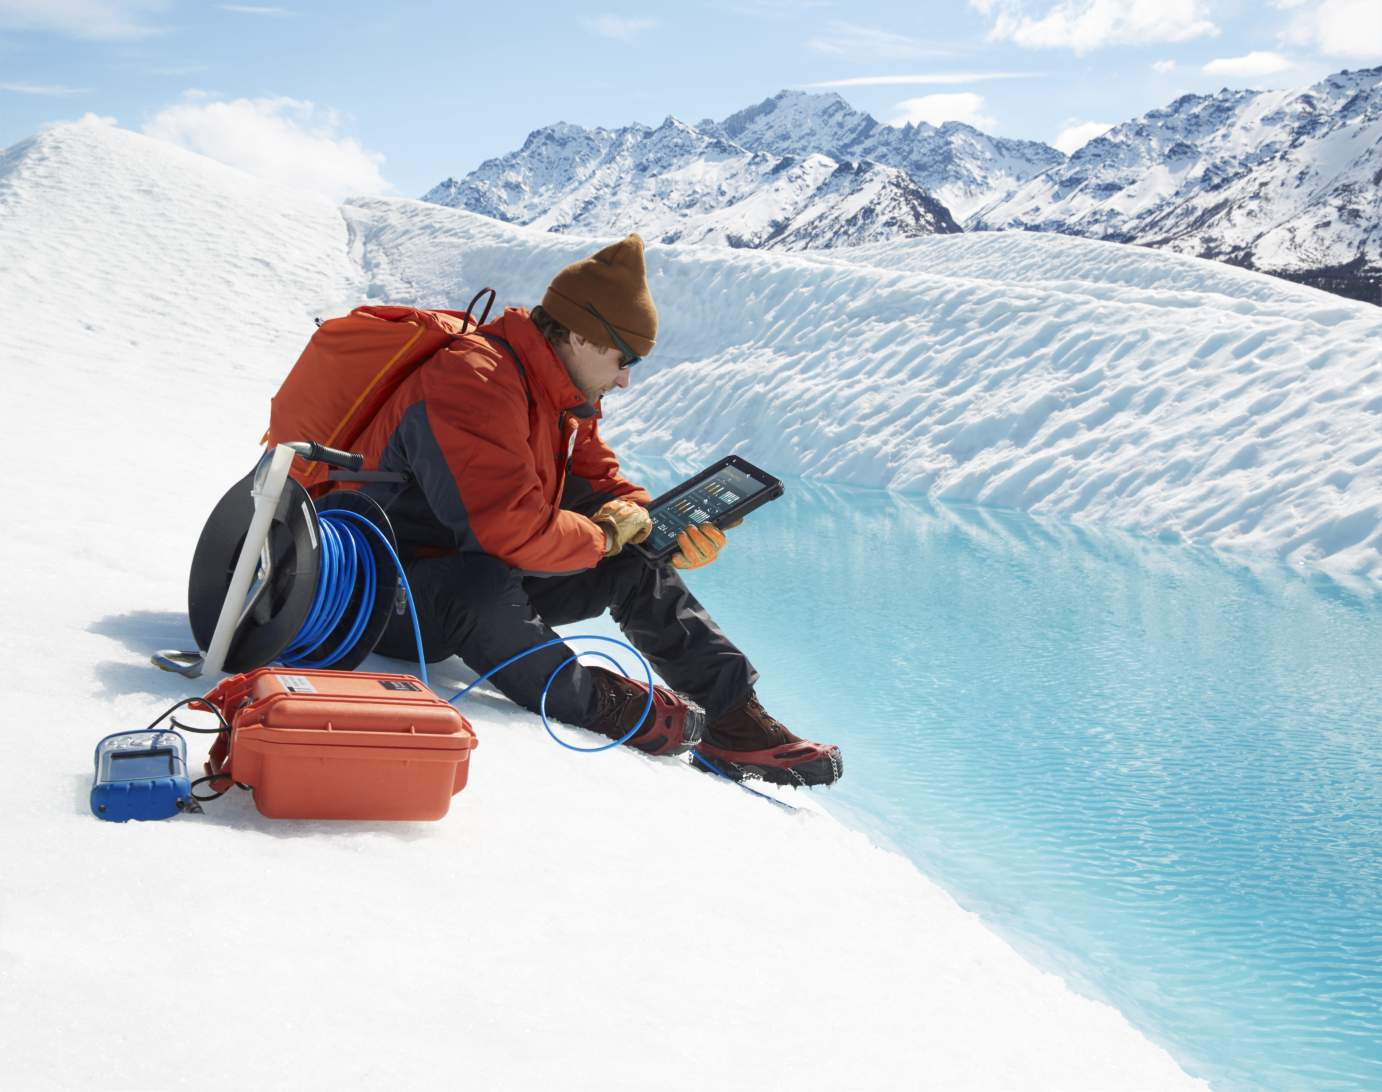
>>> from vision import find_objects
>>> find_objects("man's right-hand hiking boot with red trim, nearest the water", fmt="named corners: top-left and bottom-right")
top-left (697, 694), bottom-right (844, 787)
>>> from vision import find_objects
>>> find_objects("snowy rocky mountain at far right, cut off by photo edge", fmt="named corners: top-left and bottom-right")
top-left (967, 68), bottom-right (1382, 301)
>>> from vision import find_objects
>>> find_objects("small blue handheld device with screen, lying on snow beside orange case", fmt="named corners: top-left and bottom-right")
top-left (91, 731), bottom-right (195, 822)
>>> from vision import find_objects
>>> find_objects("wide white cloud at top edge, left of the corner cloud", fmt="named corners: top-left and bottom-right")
top-left (970, 0), bottom-right (1219, 54)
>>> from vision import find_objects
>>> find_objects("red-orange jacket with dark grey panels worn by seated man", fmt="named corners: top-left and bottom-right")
top-left (345, 308), bottom-right (651, 574)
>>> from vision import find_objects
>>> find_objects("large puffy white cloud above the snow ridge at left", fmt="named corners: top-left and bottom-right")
top-left (144, 91), bottom-right (390, 200)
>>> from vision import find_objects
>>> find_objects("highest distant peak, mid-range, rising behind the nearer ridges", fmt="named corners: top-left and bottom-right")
top-left (699, 91), bottom-right (1066, 223)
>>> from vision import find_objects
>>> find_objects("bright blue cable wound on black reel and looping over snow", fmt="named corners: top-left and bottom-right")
top-left (279, 509), bottom-right (652, 755)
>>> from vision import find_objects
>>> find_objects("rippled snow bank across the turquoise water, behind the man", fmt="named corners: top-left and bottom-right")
top-left (347, 199), bottom-right (1382, 578)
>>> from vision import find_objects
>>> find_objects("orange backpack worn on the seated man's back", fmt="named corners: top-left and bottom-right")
top-left (264, 289), bottom-right (493, 495)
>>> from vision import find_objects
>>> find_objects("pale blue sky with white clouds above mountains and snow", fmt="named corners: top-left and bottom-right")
top-left (0, 0), bottom-right (1382, 196)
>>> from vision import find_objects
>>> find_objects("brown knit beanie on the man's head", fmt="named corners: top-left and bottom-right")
top-left (542, 235), bottom-right (658, 357)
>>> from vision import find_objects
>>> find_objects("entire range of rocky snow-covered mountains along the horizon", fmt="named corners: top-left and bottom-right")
top-left (424, 75), bottom-right (1382, 303)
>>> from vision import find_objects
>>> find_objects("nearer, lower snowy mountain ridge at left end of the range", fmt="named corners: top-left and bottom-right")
top-left (423, 117), bottom-right (960, 250)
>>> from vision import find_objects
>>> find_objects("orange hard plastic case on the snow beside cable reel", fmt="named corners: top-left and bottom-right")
top-left (205, 668), bottom-right (477, 820)
